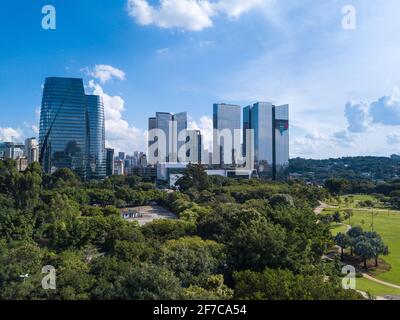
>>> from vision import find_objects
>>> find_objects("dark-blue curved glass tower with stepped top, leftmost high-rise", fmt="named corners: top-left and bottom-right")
top-left (39, 77), bottom-right (106, 180)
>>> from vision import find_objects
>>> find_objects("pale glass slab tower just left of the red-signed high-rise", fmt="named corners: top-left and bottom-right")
top-left (213, 103), bottom-right (241, 167)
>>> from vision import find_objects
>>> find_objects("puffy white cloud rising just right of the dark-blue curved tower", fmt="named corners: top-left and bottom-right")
top-left (89, 80), bottom-right (146, 153)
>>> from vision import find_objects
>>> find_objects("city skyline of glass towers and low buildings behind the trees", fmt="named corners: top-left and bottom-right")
top-left (0, 77), bottom-right (289, 181)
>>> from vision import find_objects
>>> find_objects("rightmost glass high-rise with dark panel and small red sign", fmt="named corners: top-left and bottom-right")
top-left (243, 102), bottom-right (289, 179)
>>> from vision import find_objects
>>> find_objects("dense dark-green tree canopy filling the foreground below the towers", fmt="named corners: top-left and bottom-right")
top-left (0, 160), bottom-right (362, 300)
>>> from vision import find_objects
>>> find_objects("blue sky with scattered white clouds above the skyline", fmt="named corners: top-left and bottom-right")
top-left (0, 0), bottom-right (400, 158)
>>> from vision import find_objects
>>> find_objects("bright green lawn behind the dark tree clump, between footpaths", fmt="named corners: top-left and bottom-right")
top-left (344, 210), bottom-right (400, 285)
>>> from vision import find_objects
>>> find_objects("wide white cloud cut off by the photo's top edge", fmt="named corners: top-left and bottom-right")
top-left (127, 0), bottom-right (271, 31)
